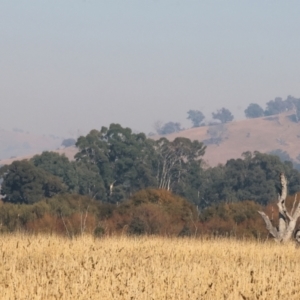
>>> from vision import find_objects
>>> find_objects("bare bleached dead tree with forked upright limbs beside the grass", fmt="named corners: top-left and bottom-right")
top-left (258, 173), bottom-right (300, 243)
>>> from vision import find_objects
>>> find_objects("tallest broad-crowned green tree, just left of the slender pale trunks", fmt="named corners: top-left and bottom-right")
top-left (76, 124), bottom-right (155, 202)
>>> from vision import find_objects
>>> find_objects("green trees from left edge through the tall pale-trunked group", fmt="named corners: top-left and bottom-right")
top-left (0, 124), bottom-right (205, 204)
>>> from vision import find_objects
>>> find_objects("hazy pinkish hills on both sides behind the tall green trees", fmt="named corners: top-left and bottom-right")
top-left (0, 112), bottom-right (300, 166)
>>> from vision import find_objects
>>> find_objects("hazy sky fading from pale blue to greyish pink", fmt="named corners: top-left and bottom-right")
top-left (0, 0), bottom-right (300, 136)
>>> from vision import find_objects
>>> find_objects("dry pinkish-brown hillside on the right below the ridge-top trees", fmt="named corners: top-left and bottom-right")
top-left (166, 112), bottom-right (300, 166)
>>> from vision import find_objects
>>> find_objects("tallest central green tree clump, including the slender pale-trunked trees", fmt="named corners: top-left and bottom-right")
top-left (76, 124), bottom-right (205, 203)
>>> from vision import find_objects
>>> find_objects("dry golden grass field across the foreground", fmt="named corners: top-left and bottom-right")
top-left (0, 234), bottom-right (300, 300)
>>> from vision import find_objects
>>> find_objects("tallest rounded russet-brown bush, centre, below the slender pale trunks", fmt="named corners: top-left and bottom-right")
top-left (110, 189), bottom-right (198, 235)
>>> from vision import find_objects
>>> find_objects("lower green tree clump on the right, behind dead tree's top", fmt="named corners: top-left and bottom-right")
top-left (197, 152), bottom-right (300, 207)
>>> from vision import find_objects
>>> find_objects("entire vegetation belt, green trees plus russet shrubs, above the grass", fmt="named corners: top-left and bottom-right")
top-left (0, 124), bottom-right (300, 236)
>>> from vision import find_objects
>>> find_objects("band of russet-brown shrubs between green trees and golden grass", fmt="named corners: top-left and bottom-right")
top-left (0, 189), bottom-right (271, 238)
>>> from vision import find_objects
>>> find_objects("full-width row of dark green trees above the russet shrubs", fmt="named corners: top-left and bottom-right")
top-left (0, 124), bottom-right (300, 208)
